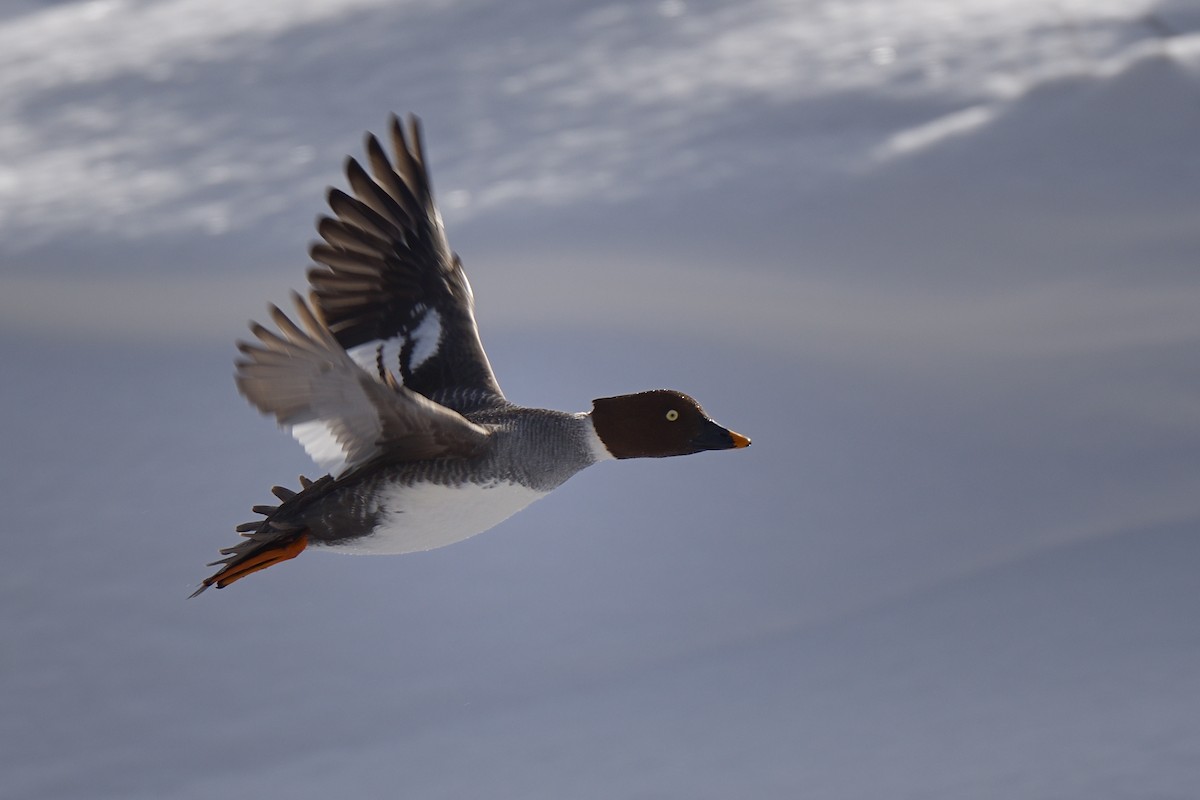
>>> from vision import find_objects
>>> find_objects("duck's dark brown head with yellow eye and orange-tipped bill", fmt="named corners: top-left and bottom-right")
top-left (592, 389), bottom-right (750, 458)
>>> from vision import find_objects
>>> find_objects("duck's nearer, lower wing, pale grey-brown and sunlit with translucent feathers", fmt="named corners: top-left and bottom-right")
top-left (235, 295), bottom-right (490, 475)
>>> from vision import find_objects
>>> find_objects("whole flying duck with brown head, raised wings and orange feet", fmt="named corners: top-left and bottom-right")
top-left (192, 115), bottom-right (750, 597)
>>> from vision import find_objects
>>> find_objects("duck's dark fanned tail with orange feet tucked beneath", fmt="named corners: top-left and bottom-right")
top-left (192, 475), bottom-right (334, 597)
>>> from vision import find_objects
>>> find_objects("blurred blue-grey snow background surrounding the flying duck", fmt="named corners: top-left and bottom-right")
top-left (0, 0), bottom-right (1200, 799)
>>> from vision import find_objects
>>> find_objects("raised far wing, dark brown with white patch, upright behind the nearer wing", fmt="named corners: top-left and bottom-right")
top-left (308, 115), bottom-right (504, 411)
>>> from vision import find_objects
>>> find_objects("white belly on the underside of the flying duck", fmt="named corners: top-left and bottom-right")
top-left (329, 481), bottom-right (547, 555)
